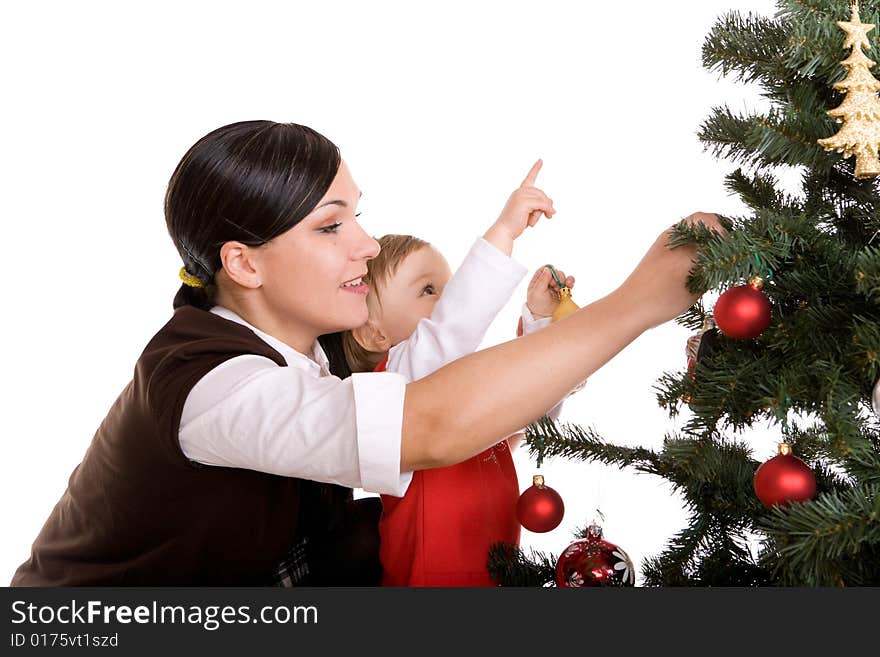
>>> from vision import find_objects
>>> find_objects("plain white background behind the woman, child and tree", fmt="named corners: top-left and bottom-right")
top-left (0, 0), bottom-right (792, 582)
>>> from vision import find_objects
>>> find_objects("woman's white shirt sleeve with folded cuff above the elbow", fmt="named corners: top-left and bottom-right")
top-left (179, 355), bottom-right (412, 497)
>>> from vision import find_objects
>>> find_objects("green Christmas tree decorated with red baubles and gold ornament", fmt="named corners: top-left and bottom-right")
top-left (490, 0), bottom-right (880, 586)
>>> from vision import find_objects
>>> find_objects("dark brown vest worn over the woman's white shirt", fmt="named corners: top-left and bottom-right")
top-left (12, 306), bottom-right (326, 586)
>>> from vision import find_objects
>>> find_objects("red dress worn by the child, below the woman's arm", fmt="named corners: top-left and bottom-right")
top-left (374, 356), bottom-right (520, 586)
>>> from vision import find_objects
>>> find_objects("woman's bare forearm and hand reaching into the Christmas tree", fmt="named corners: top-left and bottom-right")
top-left (400, 213), bottom-right (724, 471)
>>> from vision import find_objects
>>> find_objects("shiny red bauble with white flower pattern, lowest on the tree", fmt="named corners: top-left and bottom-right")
top-left (556, 525), bottom-right (636, 587)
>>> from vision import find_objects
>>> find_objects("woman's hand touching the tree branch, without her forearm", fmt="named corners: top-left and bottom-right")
top-left (619, 212), bottom-right (727, 328)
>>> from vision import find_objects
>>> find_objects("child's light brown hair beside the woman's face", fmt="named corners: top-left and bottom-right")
top-left (342, 235), bottom-right (430, 372)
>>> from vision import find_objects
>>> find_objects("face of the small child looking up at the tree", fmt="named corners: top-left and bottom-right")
top-left (376, 245), bottom-right (452, 346)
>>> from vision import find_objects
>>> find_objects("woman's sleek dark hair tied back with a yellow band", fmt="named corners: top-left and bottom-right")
top-left (165, 121), bottom-right (341, 310)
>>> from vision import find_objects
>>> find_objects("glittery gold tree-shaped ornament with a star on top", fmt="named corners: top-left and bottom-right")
top-left (818, 1), bottom-right (880, 178)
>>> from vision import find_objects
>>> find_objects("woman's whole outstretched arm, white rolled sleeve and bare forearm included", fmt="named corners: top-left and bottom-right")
top-left (179, 215), bottom-right (723, 496)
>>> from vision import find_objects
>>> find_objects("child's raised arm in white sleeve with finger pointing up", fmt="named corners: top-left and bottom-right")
top-left (386, 160), bottom-right (555, 381)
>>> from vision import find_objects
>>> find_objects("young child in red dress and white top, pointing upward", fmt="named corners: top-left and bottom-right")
top-left (345, 162), bottom-right (574, 586)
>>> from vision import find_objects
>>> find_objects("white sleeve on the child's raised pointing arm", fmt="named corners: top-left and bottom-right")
top-left (386, 237), bottom-right (526, 381)
